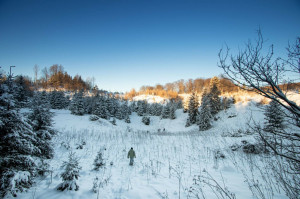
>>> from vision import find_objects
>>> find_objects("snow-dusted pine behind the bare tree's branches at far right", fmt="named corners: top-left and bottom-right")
top-left (263, 100), bottom-right (284, 152)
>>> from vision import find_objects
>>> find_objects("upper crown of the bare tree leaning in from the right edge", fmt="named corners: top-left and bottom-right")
top-left (219, 30), bottom-right (300, 124)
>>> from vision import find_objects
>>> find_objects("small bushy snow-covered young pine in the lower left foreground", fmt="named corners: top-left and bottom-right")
top-left (57, 152), bottom-right (81, 191)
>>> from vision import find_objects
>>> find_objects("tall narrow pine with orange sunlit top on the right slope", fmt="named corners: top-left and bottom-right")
top-left (208, 77), bottom-right (221, 115)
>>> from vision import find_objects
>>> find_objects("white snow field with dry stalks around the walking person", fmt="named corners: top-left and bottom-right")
top-left (17, 102), bottom-right (287, 199)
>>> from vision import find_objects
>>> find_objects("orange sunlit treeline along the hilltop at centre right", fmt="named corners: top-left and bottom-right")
top-left (125, 77), bottom-right (239, 99)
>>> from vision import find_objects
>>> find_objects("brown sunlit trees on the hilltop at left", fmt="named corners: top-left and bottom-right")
top-left (33, 64), bottom-right (94, 91)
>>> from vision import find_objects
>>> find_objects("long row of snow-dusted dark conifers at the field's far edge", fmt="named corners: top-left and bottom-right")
top-left (69, 91), bottom-right (182, 125)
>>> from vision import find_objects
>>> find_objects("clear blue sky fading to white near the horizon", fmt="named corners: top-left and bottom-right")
top-left (0, 0), bottom-right (300, 91)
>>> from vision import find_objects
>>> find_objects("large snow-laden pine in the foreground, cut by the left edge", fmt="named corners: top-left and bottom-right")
top-left (0, 77), bottom-right (41, 197)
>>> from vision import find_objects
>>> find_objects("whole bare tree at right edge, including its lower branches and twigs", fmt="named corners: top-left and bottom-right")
top-left (219, 30), bottom-right (300, 198)
